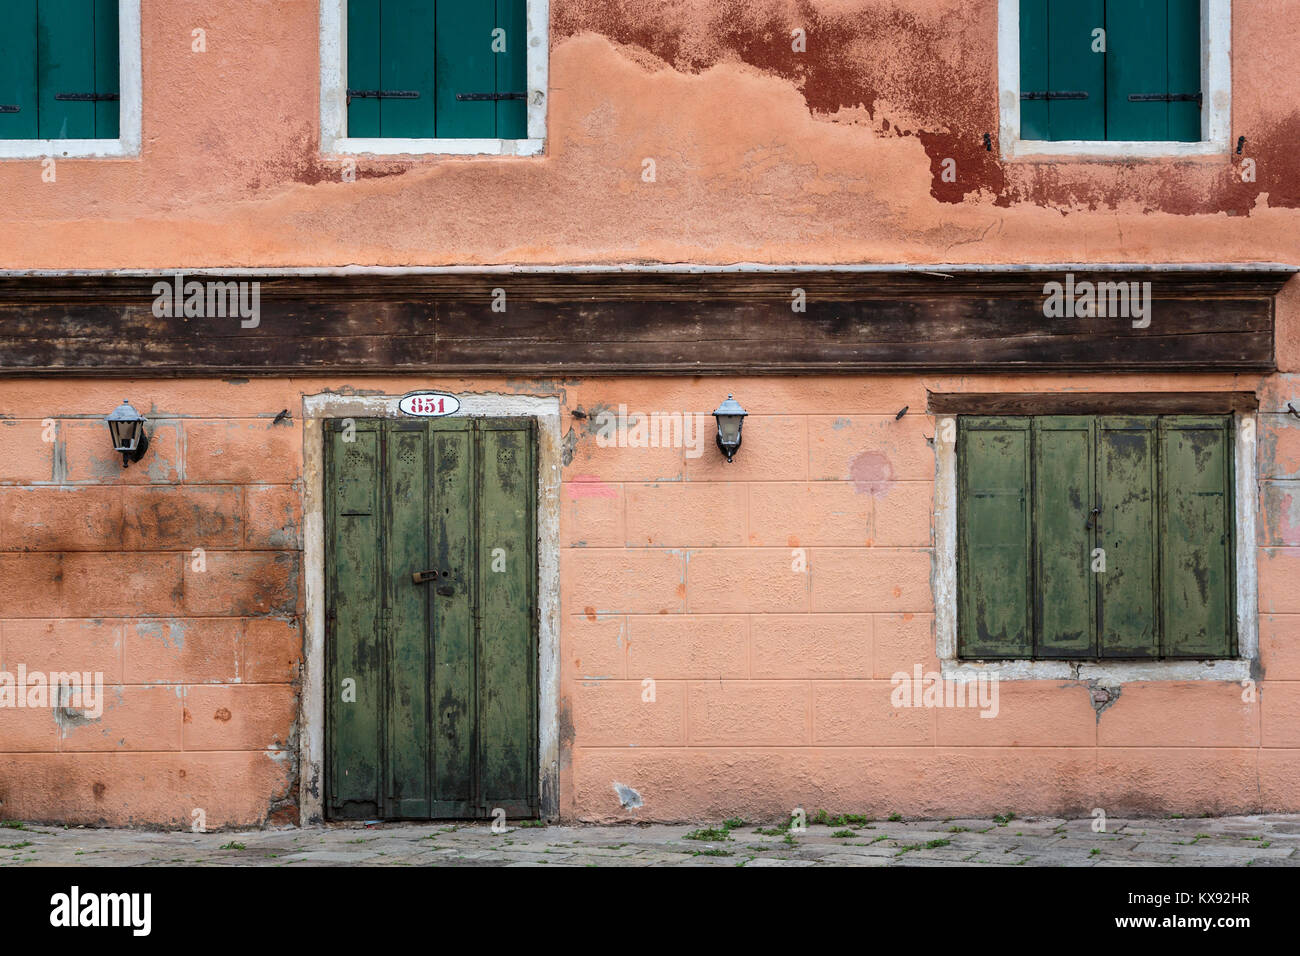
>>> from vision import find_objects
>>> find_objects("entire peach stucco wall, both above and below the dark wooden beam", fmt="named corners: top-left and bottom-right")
top-left (0, 0), bottom-right (1300, 826)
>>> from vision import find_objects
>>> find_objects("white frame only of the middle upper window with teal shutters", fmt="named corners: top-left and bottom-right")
top-left (321, 0), bottom-right (550, 156)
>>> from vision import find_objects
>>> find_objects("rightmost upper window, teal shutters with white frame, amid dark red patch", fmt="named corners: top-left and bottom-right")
top-left (1000, 0), bottom-right (1231, 157)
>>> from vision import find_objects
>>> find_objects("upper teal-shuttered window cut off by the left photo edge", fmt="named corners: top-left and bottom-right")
top-left (0, 0), bottom-right (140, 157)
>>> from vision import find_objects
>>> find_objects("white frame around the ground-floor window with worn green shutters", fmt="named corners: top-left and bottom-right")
top-left (933, 411), bottom-right (1260, 687)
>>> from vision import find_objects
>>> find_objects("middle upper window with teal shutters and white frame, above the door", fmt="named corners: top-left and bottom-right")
top-left (321, 0), bottom-right (546, 153)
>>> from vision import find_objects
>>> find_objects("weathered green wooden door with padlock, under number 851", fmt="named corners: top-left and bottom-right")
top-left (325, 419), bottom-right (537, 819)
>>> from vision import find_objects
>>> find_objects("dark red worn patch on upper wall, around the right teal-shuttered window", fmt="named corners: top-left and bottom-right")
top-left (553, 0), bottom-right (1300, 216)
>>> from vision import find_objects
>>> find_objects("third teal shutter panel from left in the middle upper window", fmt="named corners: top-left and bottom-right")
top-left (434, 0), bottom-right (496, 139)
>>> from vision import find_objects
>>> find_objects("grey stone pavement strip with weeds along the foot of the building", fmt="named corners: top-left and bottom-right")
top-left (0, 814), bottom-right (1300, 866)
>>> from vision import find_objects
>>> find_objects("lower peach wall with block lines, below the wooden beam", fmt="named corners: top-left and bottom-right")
top-left (0, 376), bottom-right (1300, 826)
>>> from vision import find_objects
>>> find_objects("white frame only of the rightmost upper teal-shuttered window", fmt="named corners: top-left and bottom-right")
top-left (997, 0), bottom-right (1232, 160)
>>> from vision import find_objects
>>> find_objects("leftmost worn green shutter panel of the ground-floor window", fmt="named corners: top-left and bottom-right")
top-left (957, 416), bottom-right (1034, 658)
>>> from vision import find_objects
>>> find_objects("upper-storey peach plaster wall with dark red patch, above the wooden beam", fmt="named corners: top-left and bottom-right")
top-left (0, 0), bottom-right (1300, 268)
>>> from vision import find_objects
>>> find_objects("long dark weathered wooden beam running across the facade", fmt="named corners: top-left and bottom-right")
top-left (0, 267), bottom-right (1291, 376)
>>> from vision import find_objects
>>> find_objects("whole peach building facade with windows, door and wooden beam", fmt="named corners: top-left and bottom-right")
top-left (0, 0), bottom-right (1300, 827)
